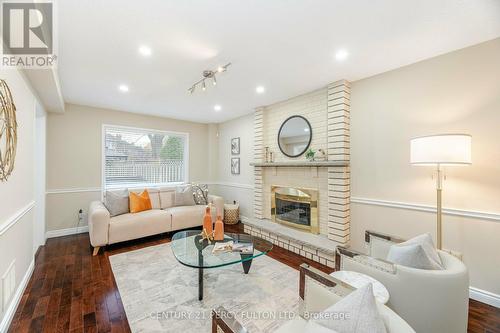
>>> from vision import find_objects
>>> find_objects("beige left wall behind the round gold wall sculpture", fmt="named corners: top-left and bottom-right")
top-left (0, 69), bottom-right (39, 331)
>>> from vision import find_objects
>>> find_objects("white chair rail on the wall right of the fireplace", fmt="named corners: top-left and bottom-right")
top-left (351, 197), bottom-right (500, 222)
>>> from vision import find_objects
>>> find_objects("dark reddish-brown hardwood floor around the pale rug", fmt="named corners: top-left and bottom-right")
top-left (9, 226), bottom-right (500, 333)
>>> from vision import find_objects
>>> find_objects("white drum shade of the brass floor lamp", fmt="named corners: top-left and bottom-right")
top-left (410, 134), bottom-right (472, 165)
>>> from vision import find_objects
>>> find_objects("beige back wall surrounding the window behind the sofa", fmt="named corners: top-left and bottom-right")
top-left (47, 104), bottom-right (209, 231)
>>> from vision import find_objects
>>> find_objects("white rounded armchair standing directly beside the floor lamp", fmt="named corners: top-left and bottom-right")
top-left (336, 231), bottom-right (469, 333)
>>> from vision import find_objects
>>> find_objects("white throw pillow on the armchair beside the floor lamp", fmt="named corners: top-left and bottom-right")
top-left (387, 233), bottom-right (444, 270)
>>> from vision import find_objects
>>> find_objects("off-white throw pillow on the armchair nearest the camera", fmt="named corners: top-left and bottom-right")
top-left (311, 283), bottom-right (387, 333)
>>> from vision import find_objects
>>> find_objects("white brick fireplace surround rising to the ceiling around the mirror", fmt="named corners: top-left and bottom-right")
top-left (254, 80), bottom-right (350, 248)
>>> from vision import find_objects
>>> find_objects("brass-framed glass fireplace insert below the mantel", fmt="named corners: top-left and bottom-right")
top-left (271, 186), bottom-right (319, 234)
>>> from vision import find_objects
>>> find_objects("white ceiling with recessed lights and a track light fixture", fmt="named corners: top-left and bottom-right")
top-left (58, 0), bottom-right (500, 122)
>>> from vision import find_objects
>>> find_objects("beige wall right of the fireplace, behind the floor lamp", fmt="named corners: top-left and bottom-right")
top-left (351, 39), bottom-right (500, 295)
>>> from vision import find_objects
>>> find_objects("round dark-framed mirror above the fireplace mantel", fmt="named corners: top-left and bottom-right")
top-left (278, 116), bottom-right (312, 157)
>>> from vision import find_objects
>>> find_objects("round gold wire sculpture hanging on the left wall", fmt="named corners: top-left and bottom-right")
top-left (0, 79), bottom-right (17, 181)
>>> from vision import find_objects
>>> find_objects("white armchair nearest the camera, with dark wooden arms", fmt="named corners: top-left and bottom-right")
top-left (212, 264), bottom-right (415, 333)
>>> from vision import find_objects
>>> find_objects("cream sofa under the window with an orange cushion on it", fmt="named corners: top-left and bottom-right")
top-left (88, 187), bottom-right (224, 255)
